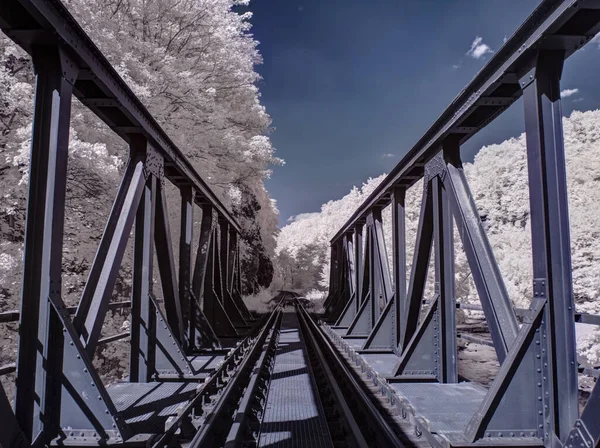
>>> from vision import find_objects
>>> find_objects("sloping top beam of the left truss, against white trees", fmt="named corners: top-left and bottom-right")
top-left (0, 0), bottom-right (240, 232)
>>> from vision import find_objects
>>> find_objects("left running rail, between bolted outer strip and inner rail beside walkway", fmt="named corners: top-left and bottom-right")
top-left (188, 307), bottom-right (282, 448)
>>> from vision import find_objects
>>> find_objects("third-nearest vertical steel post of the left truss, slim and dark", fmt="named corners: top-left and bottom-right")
top-left (179, 186), bottom-right (194, 349)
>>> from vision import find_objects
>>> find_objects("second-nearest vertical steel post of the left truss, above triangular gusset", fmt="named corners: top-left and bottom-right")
top-left (129, 175), bottom-right (156, 383)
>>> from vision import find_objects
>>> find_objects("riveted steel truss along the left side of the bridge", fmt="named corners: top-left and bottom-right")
top-left (0, 0), bottom-right (254, 447)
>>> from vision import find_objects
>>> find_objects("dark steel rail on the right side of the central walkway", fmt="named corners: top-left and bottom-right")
top-left (297, 305), bottom-right (404, 447)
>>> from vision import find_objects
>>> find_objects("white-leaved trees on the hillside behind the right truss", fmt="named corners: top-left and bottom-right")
top-left (277, 110), bottom-right (600, 362)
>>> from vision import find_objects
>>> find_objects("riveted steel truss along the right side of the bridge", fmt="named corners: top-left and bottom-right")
top-left (325, 0), bottom-right (600, 447)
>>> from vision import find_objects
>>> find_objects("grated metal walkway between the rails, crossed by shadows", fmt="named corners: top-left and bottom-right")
top-left (258, 312), bottom-right (333, 448)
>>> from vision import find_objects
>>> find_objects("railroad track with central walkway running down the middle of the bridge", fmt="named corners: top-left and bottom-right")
top-left (169, 303), bottom-right (414, 448)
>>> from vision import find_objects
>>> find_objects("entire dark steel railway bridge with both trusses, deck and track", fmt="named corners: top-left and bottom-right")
top-left (0, 0), bottom-right (600, 448)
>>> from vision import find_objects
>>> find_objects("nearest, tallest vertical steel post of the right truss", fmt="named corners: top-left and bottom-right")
top-left (521, 51), bottom-right (578, 443)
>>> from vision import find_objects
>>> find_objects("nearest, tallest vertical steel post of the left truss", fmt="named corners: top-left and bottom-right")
top-left (15, 46), bottom-right (78, 443)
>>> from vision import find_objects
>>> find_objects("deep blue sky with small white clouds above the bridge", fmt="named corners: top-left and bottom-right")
top-left (250, 0), bottom-right (600, 225)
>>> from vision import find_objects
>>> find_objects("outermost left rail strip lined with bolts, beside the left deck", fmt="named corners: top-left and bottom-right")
top-left (152, 308), bottom-right (277, 448)
